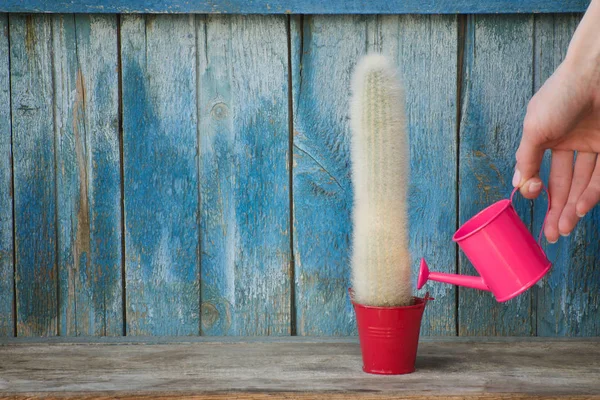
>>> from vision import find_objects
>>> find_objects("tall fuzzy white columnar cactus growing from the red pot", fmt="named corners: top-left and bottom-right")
top-left (350, 54), bottom-right (413, 307)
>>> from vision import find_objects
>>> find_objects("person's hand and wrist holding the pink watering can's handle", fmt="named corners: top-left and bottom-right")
top-left (513, 0), bottom-right (600, 243)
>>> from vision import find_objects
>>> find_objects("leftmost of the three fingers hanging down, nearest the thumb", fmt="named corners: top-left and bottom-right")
top-left (544, 150), bottom-right (573, 243)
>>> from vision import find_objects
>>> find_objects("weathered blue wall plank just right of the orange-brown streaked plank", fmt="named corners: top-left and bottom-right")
top-left (121, 16), bottom-right (200, 335)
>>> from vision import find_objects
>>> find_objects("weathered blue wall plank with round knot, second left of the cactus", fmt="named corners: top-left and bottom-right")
top-left (197, 16), bottom-right (291, 335)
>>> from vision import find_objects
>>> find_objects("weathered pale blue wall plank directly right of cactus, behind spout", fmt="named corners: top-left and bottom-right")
top-left (369, 16), bottom-right (458, 335)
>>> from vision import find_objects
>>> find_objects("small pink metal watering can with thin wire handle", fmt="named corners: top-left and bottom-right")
top-left (417, 189), bottom-right (552, 302)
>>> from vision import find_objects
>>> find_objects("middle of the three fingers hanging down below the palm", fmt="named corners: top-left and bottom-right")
top-left (558, 152), bottom-right (597, 236)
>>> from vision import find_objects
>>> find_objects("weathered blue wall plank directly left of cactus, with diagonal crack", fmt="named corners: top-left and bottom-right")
top-left (291, 16), bottom-right (366, 335)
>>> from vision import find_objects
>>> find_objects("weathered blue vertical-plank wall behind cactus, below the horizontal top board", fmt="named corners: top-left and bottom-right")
top-left (0, 11), bottom-right (600, 336)
